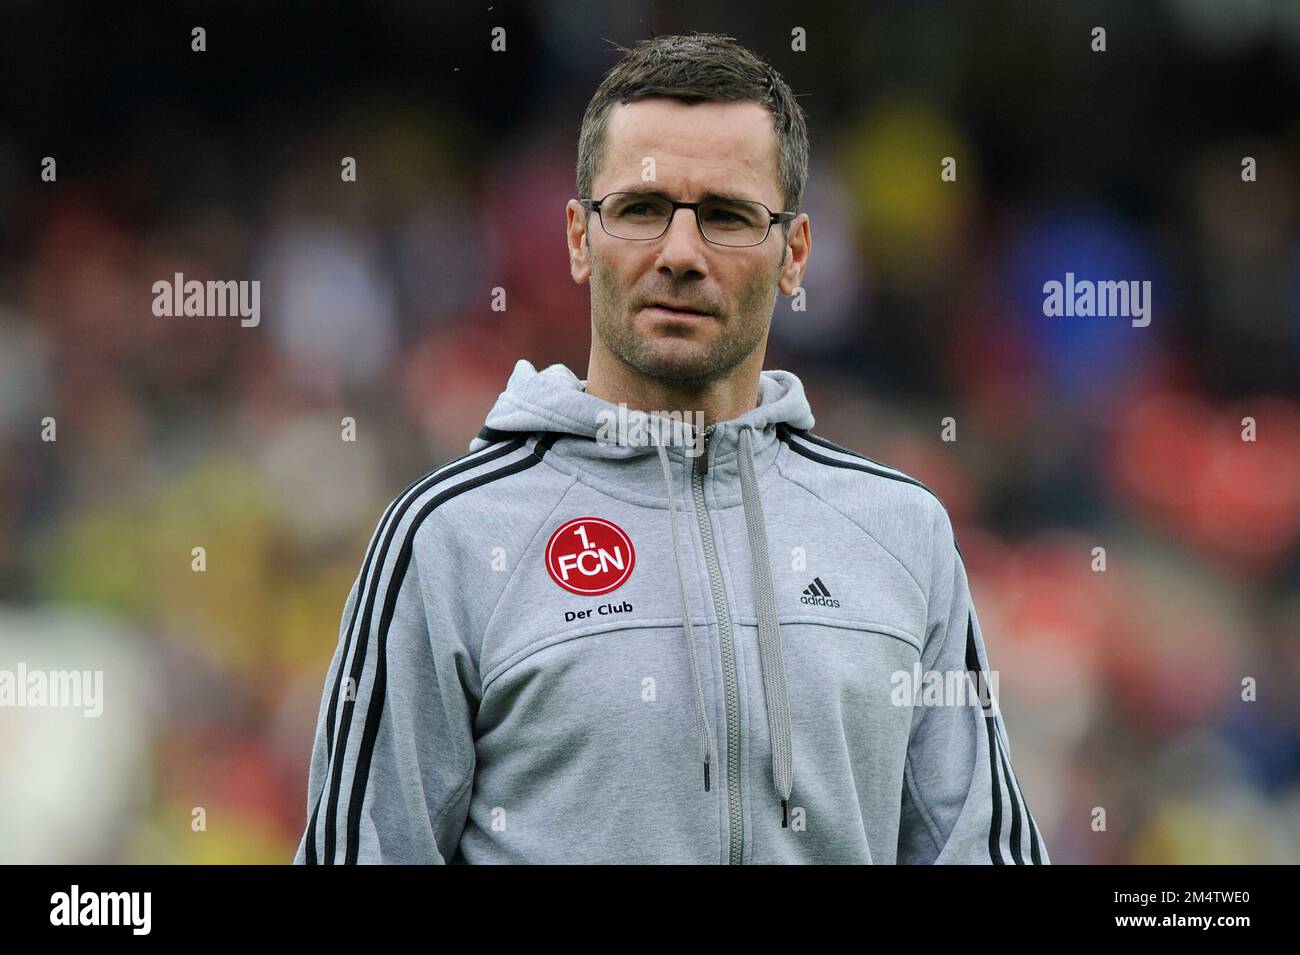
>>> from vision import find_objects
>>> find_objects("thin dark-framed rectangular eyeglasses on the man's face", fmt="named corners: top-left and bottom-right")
top-left (579, 192), bottom-right (796, 248)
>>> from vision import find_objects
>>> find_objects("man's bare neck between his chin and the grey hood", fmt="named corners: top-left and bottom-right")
top-left (586, 353), bottom-right (762, 427)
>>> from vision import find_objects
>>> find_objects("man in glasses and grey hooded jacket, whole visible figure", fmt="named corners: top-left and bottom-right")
top-left (296, 35), bottom-right (1048, 863)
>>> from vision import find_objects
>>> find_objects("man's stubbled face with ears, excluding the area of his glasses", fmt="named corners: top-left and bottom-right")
top-left (568, 99), bottom-right (807, 385)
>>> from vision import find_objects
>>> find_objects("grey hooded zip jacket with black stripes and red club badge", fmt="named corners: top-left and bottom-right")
top-left (295, 360), bottom-right (1048, 864)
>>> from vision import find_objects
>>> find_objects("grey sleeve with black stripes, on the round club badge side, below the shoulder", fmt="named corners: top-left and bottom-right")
top-left (294, 508), bottom-right (477, 865)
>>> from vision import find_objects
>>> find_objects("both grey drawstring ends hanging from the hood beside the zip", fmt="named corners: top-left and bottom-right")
top-left (655, 425), bottom-right (794, 828)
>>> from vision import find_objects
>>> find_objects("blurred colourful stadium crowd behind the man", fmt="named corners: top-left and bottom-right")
top-left (0, 0), bottom-right (1300, 863)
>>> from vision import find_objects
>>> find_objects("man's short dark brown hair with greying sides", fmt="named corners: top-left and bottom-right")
top-left (577, 34), bottom-right (809, 227)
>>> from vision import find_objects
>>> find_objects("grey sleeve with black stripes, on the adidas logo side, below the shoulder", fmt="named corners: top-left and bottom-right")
top-left (898, 499), bottom-right (1049, 864)
